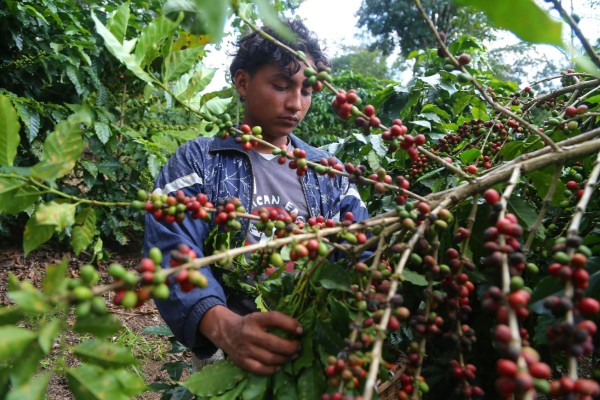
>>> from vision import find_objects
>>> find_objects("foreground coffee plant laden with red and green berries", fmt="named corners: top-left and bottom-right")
top-left (0, 0), bottom-right (600, 399)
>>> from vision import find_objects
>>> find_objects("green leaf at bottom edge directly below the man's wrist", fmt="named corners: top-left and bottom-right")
top-left (181, 360), bottom-right (247, 398)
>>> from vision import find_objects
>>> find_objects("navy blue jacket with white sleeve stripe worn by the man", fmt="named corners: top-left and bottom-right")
top-left (144, 135), bottom-right (368, 358)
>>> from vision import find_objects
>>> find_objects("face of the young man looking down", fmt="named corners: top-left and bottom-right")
top-left (235, 64), bottom-right (312, 146)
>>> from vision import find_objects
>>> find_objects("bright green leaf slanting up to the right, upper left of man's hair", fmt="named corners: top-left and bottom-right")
top-left (135, 15), bottom-right (178, 68)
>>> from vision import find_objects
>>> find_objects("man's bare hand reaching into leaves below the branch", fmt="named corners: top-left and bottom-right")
top-left (199, 306), bottom-right (302, 375)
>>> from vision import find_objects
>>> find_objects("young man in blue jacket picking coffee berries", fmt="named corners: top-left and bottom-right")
top-left (145, 20), bottom-right (367, 375)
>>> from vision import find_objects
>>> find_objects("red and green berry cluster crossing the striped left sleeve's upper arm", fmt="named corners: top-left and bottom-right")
top-left (131, 189), bottom-right (214, 223)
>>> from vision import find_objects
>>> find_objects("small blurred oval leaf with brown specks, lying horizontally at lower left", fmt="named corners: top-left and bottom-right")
top-left (73, 339), bottom-right (137, 367)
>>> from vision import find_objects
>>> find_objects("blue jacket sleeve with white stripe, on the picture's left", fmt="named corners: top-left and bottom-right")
top-left (144, 143), bottom-right (226, 358)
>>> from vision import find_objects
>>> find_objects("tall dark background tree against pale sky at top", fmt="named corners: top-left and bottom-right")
top-left (357, 0), bottom-right (493, 57)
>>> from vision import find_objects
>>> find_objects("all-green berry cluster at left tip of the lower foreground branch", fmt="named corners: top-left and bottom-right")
top-left (68, 264), bottom-right (108, 317)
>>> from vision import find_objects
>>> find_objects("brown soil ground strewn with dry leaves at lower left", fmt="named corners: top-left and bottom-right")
top-left (0, 246), bottom-right (190, 400)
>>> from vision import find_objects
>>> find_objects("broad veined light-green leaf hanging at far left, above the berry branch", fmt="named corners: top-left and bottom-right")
top-left (41, 119), bottom-right (83, 179)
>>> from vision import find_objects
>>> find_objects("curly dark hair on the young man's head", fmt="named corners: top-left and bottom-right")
top-left (229, 19), bottom-right (329, 83)
